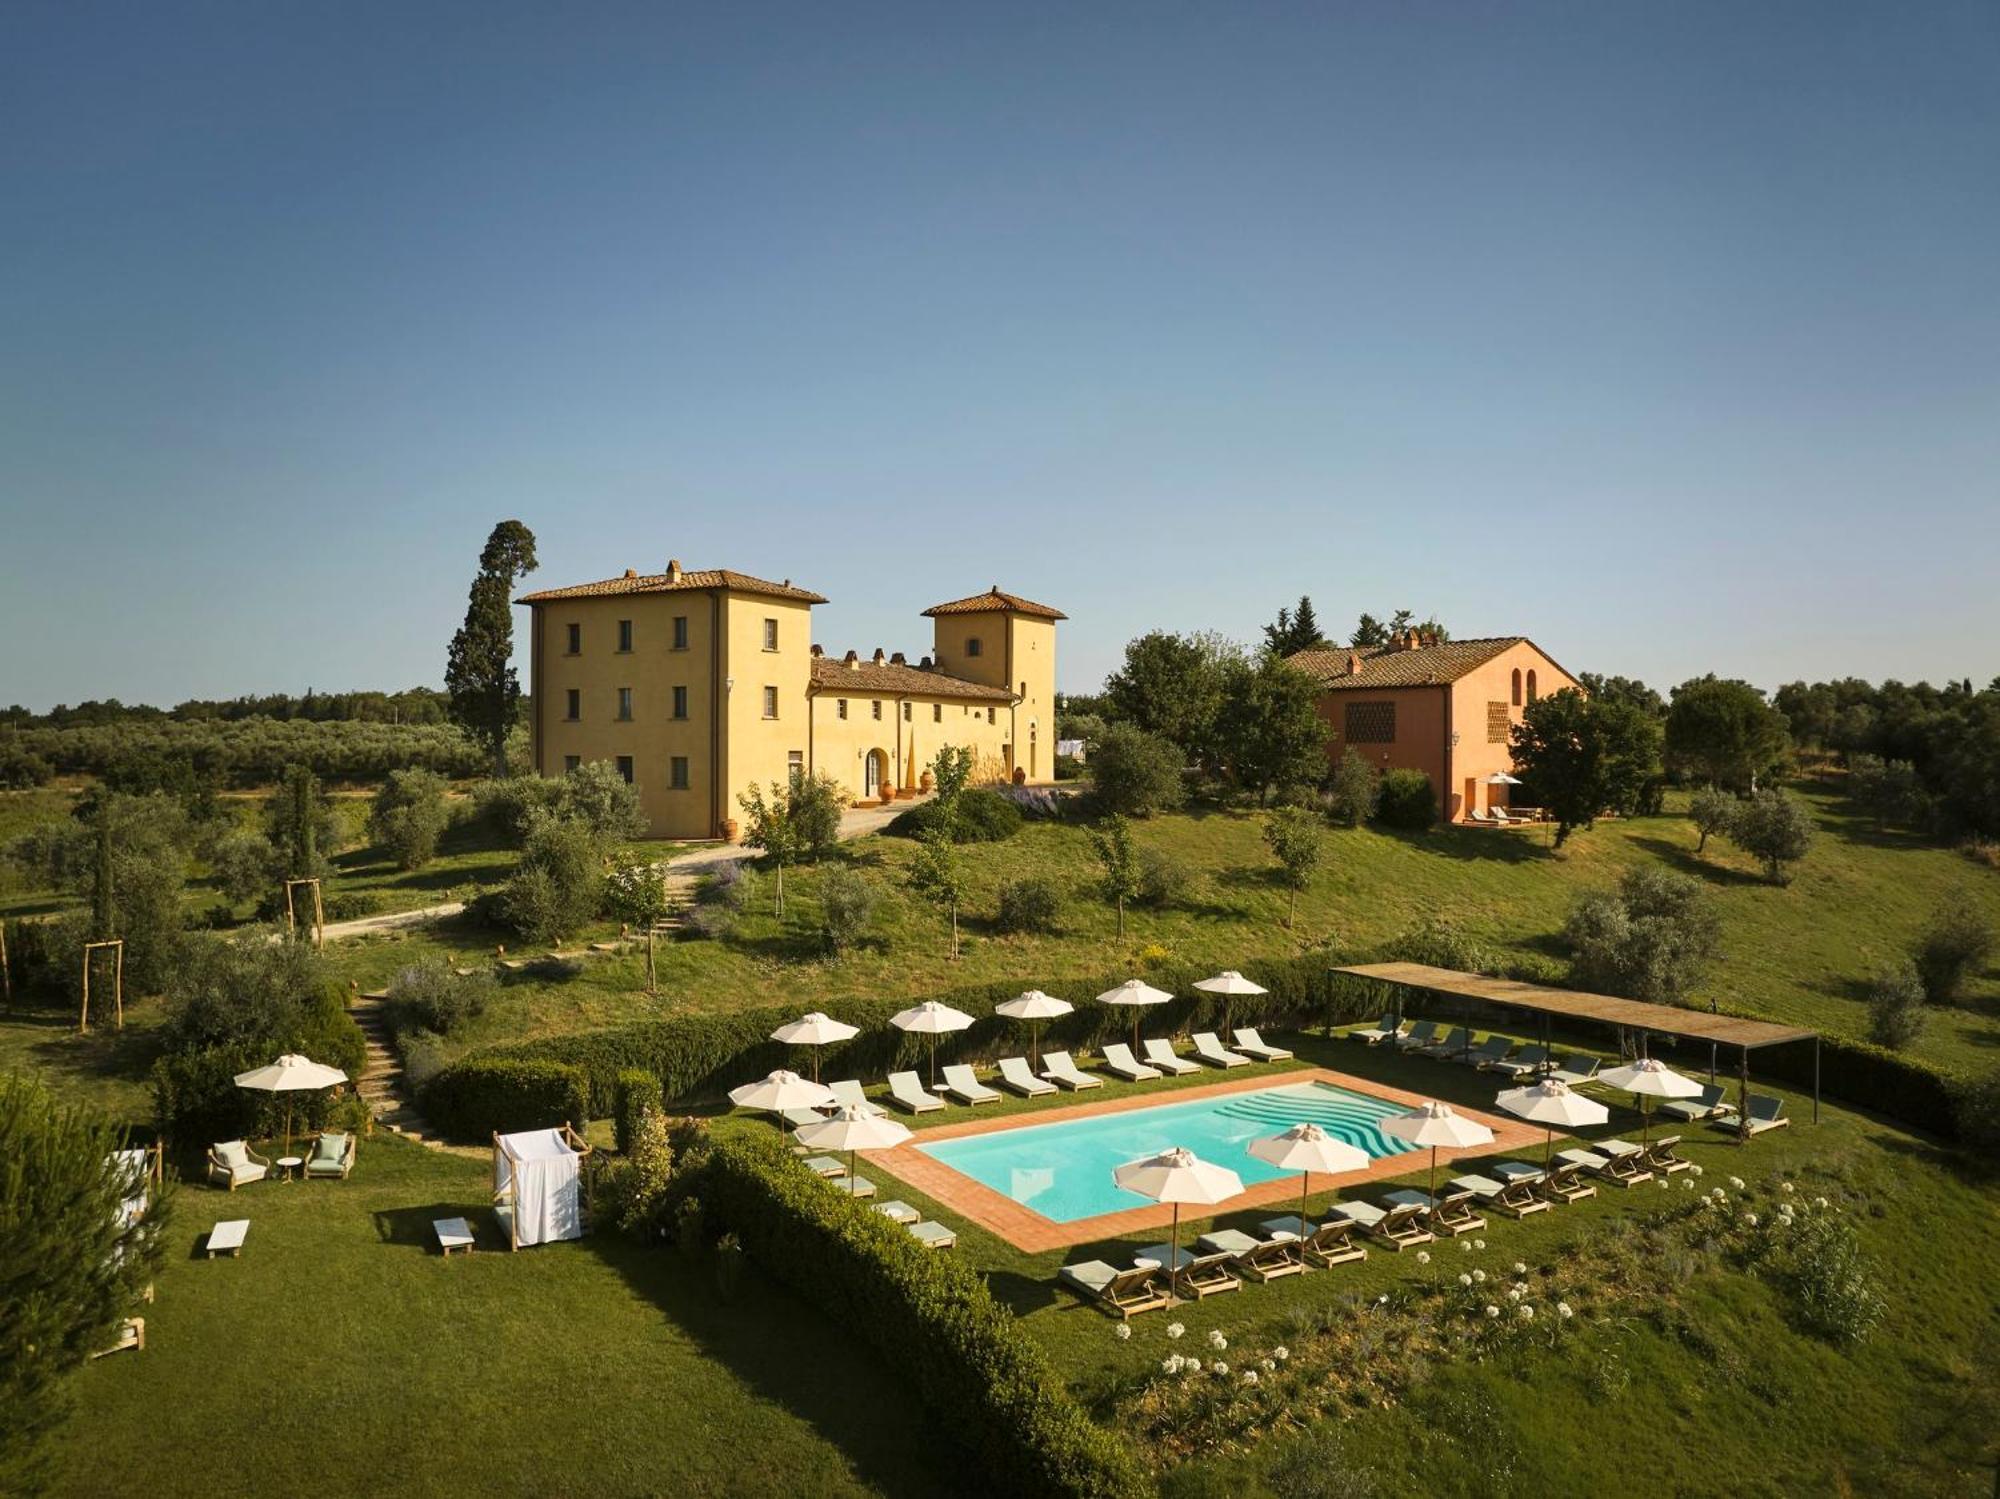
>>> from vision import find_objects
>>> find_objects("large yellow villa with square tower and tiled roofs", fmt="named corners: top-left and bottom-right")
top-left (518, 562), bottom-right (1068, 837)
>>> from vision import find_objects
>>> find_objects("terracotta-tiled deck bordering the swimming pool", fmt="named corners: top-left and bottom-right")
top-left (862, 1067), bottom-right (1546, 1253)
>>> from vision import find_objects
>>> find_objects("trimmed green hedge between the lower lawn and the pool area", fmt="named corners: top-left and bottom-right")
top-left (700, 1137), bottom-right (1152, 1499)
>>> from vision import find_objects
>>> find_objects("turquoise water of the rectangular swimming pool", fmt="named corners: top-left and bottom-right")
top-left (916, 1083), bottom-right (1416, 1223)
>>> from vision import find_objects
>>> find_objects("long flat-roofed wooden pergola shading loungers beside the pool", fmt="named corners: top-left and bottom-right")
top-left (1332, 963), bottom-right (1820, 1129)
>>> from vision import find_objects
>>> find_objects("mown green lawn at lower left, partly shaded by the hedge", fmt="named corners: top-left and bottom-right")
top-left (58, 1137), bottom-right (950, 1499)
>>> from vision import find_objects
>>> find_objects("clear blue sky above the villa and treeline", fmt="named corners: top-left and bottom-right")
top-left (0, 0), bottom-right (2000, 708)
